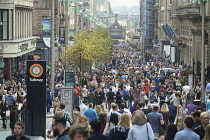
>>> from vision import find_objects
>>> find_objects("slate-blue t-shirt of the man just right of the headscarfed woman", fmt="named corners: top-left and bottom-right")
top-left (147, 112), bottom-right (163, 133)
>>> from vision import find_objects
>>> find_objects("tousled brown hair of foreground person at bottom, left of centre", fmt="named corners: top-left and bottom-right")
top-left (69, 123), bottom-right (90, 140)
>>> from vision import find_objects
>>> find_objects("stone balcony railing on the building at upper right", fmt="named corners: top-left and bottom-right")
top-left (176, 5), bottom-right (201, 17)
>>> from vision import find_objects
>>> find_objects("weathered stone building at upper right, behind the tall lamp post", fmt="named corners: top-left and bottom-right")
top-left (172, 0), bottom-right (210, 66)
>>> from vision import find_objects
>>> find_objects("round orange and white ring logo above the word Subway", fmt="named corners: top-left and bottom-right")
top-left (29, 64), bottom-right (43, 77)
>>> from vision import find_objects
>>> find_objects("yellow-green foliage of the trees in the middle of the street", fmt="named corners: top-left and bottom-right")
top-left (66, 28), bottom-right (113, 70)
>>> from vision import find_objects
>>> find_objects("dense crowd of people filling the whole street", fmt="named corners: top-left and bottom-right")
top-left (3, 44), bottom-right (210, 140)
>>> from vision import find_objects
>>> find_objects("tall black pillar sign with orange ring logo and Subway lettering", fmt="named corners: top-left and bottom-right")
top-left (25, 60), bottom-right (46, 138)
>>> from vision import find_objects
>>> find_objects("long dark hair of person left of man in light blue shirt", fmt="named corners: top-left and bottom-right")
top-left (165, 123), bottom-right (178, 140)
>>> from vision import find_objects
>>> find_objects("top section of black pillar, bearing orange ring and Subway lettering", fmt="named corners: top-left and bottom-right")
top-left (26, 61), bottom-right (46, 85)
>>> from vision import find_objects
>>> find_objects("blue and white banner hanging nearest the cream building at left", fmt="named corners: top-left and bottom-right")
top-left (42, 18), bottom-right (51, 47)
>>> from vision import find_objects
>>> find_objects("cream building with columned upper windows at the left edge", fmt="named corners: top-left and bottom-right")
top-left (0, 0), bottom-right (36, 79)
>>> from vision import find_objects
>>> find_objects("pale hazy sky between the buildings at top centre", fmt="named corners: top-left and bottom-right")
top-left (109, 0), bottom-right (139, 8)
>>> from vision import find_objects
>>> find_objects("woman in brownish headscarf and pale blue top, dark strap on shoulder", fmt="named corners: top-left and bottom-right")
top-left (126, 110), bottom-right (156, 140)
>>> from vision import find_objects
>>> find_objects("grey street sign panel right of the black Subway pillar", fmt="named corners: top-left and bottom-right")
top-left (60, 88), bottom-right (74, 116)
